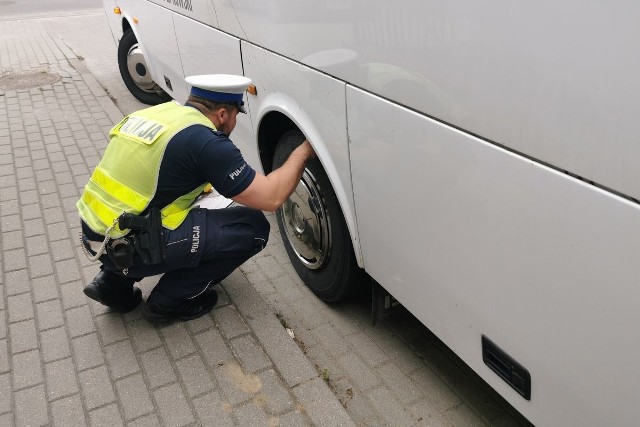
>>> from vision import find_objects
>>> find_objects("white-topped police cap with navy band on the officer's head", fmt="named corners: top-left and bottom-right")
top-left (185, 74), bottom-right (251, 113)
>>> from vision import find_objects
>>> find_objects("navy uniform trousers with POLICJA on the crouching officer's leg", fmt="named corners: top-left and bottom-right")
top-left (84, 206), bottom-right (270, 306)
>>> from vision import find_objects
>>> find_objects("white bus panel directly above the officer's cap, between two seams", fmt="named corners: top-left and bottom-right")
top-left (173, 15), bottom-right (243, 102)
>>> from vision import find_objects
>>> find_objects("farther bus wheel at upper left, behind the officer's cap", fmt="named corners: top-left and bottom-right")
top-left (118, 29), bottom-right (171, 105)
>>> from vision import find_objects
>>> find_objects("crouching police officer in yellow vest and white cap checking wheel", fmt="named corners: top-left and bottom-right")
top-left (77, 74), bottom-right (315, 321)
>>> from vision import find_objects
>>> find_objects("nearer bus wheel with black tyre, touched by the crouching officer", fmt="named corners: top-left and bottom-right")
top-left (273, 130), bottom-right (366, 302)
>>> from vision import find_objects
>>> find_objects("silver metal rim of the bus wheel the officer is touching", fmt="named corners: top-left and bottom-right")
top-left (281, 170), bottom-right (331, 270)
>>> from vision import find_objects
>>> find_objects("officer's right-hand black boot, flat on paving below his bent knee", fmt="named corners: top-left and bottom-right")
top-left (142, 287), bottom-right (218, 323)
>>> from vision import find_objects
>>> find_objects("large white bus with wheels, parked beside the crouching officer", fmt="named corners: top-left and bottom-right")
top-left (99, 0), bottom-right (640, 426)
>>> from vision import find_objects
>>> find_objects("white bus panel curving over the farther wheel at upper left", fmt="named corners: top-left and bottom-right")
top-left (122, 1), bottom-right (186, 98)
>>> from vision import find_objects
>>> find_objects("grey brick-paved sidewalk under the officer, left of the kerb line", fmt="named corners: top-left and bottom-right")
top-left (0, 20), bottom-right (354, 426)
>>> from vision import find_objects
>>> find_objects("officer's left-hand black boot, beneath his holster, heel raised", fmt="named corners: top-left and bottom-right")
top-left (83, 270), bottom-right (142, 313)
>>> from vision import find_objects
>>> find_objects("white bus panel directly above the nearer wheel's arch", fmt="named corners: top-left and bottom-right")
top-left (242, 43), bottom-right (358, 253)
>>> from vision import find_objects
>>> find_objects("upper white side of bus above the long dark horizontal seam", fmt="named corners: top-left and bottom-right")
top-left (212, 0), bottom-right (640, 199)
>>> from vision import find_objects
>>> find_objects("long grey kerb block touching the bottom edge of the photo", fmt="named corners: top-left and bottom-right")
top-left (293, 378), bottom-right (352, 425)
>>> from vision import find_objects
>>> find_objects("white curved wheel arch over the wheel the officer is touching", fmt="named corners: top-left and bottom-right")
top-left (256, 98), bottom-right (364, 268)
